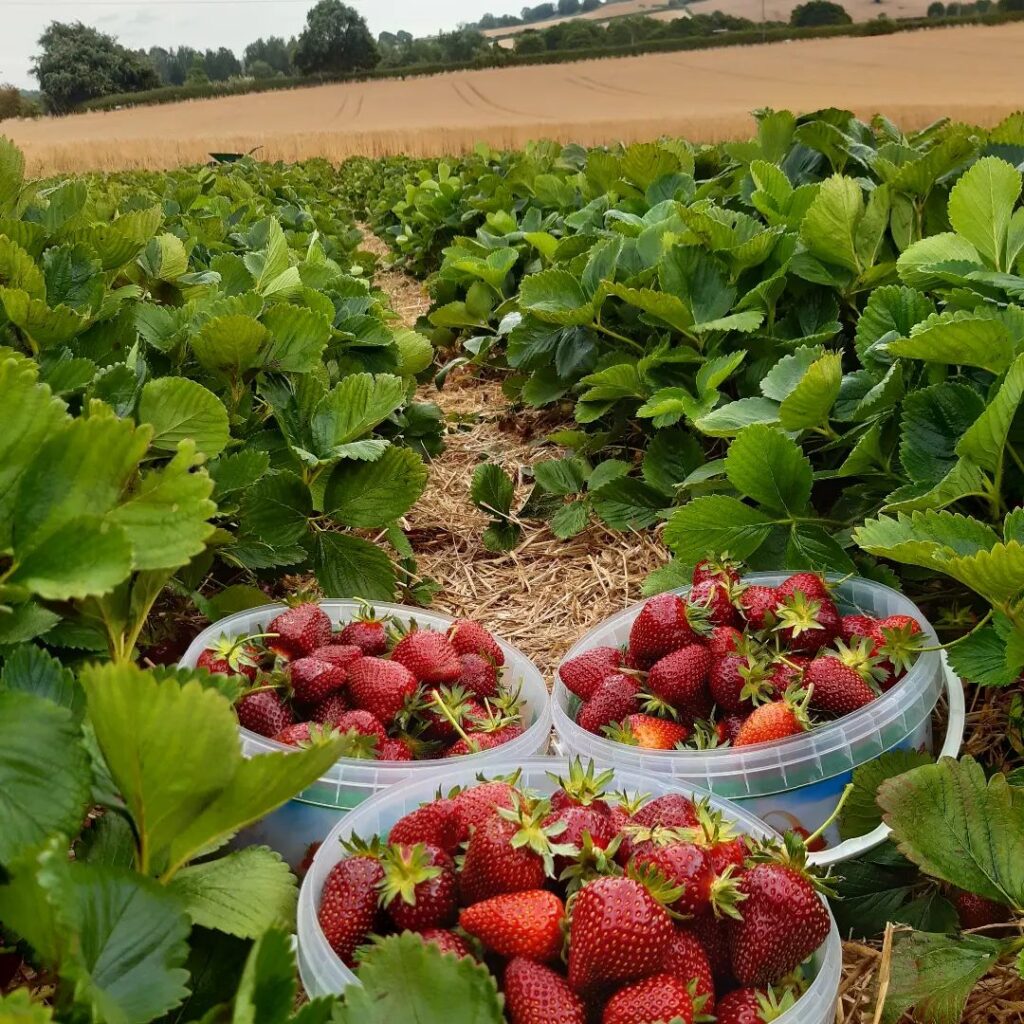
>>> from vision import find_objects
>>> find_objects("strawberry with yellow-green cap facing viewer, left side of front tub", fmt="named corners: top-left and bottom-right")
top-left (378, 843), bottom-right (459, 932)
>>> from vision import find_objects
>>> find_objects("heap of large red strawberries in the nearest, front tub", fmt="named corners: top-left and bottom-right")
top-left (317, 761), bottom-right (830, 1024)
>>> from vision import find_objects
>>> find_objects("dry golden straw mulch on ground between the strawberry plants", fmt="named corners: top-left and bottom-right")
top-left (366, 231), bottom-right (1024, 1024)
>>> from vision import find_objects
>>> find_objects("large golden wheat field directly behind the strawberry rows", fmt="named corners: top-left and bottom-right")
top-left (8, 24), bottom-right (1024, 174)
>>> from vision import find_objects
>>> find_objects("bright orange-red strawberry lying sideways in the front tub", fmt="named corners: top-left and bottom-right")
top-left (459, 889), bottom-right (565, 963)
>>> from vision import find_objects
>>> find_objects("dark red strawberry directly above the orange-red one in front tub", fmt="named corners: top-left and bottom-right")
top-left (459, 797), bottom-right (573, 904)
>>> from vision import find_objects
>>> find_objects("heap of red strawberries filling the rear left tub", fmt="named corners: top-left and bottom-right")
top-left (198, 602), bottom-right (523, 761)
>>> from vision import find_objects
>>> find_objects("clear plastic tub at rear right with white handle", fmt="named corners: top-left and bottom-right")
top-left (552, 572), bottom-right (964, 863)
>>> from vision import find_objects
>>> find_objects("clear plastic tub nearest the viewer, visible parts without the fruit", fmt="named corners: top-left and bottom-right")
top-left (297, 758), bottom-right (843, 1024)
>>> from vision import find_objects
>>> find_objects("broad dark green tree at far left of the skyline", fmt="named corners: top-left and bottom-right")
top-left (32, 22), bottom-right (160, 114)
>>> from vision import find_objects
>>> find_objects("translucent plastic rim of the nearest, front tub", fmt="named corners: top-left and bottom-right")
top-left (297, 757), bottom-right (843, 1024)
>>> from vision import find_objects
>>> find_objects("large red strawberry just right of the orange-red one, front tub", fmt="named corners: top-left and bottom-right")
top-left (568, 878), bottom-right (674, 991)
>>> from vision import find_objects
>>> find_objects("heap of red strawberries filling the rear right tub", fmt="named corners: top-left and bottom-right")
top-left (559, 559), bottom-right (923, 750)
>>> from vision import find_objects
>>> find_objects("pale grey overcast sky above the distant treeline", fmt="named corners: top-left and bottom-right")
top-left (0, 0), bottom-right (525, 89)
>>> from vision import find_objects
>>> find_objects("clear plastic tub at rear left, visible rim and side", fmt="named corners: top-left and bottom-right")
top-left (180, 600), bottom-right (551, 867)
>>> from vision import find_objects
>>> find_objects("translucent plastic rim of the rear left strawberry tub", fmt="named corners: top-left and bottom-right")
top-left (178, 598), bottom-right (552, 770)
